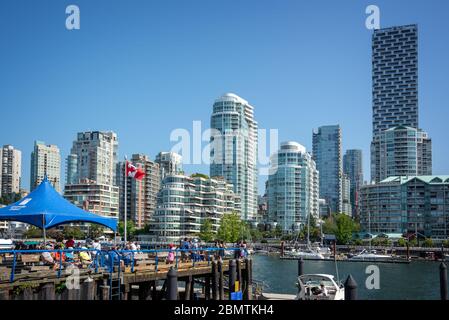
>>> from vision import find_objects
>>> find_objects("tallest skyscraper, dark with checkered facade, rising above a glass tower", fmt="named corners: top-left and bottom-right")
top-left (372, 25), bottom-right (418, 136)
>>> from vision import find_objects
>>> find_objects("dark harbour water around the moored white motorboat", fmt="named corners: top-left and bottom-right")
top-left (253, 255), bottom-right (440, 300)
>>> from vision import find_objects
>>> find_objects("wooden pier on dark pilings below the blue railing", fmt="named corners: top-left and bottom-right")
top-left (0, 259), bottom-right (252, 300)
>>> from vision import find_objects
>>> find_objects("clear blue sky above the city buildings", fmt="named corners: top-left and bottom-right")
top-left (0, 0), bottom-right (449, 193)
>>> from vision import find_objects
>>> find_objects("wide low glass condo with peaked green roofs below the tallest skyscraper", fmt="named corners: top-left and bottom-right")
top-left (360, 175), bottom-right (449, 240)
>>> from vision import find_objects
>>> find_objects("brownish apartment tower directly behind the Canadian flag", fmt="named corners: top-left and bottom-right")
top-left (118, 154), bottom-right (161, 229)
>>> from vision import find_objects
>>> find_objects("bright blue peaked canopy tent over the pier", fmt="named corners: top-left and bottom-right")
top-left (0, 177), bottom-right (117, 238)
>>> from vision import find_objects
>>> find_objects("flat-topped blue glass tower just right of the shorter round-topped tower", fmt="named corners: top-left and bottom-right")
top-left (312, 125), bottom-right (343, 213)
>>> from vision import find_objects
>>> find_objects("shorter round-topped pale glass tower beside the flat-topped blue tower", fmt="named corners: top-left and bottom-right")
top-left (267, 141), bottom-right (319, 233)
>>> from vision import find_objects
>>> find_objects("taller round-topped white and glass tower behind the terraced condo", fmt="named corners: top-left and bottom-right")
top-left (210, 93), bottom-right (258, 221)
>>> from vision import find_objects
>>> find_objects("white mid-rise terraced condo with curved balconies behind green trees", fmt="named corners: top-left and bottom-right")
top-left (150, 175), bottom-right (241, 243)
